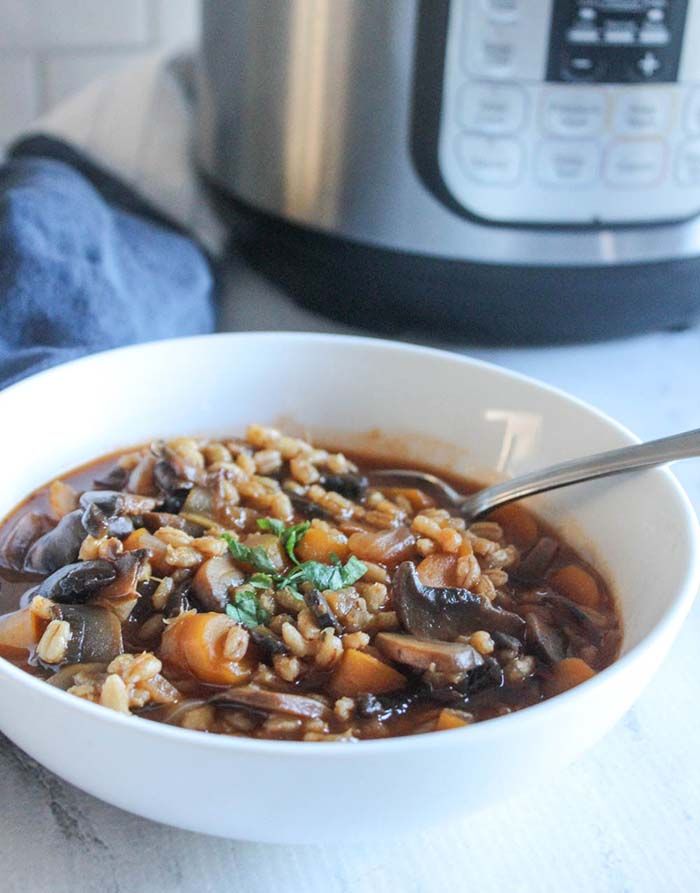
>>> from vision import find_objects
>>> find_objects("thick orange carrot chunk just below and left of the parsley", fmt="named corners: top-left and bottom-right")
top-left (161, 612), bottom-right (253, 685)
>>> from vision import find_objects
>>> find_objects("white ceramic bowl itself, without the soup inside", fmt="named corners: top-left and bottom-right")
top-left (0, 333), bottom-right (699, 843)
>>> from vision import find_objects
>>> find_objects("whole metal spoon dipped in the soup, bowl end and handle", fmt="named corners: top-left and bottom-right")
top-left (370, 428), bottom-right (700, 521)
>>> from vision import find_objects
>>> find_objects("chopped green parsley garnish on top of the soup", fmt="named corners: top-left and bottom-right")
top-left (222, 518), bottom-right (367, 604)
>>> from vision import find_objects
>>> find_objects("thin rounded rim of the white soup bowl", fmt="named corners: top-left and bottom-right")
top-left (0, 331), bottom-right (700, 760)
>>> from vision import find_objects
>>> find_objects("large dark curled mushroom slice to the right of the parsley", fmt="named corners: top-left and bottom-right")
top-left (393, 561), bottom-right (525, 641)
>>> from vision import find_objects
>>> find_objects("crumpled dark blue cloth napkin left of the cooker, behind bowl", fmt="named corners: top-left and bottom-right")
top-left (0, 137), bottom-right (215, 388)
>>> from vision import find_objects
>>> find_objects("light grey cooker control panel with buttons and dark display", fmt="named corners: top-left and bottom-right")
top-left (437, 0), bottom-right (700, 226)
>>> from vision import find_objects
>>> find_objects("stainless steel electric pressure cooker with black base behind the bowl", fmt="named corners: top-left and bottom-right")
top-left (198, 0), bottom-right (700, 340)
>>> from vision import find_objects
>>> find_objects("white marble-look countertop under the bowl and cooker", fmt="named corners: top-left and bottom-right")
top-left (0, 256), bottom-right (700, 893)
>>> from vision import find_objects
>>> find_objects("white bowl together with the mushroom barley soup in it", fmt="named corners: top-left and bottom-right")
top-left (0, 335), bottom-right (697, 841)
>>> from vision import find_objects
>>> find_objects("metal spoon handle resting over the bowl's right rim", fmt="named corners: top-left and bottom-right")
top-left (460, 429), bottom-right (700, 518)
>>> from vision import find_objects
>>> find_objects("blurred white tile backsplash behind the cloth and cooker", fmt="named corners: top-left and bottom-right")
top-left (0, 0), bottom-right (201, 148)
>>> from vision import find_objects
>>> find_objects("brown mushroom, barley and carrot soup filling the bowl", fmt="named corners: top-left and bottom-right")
top-left (0, 425), bottom-right (621, 741)
